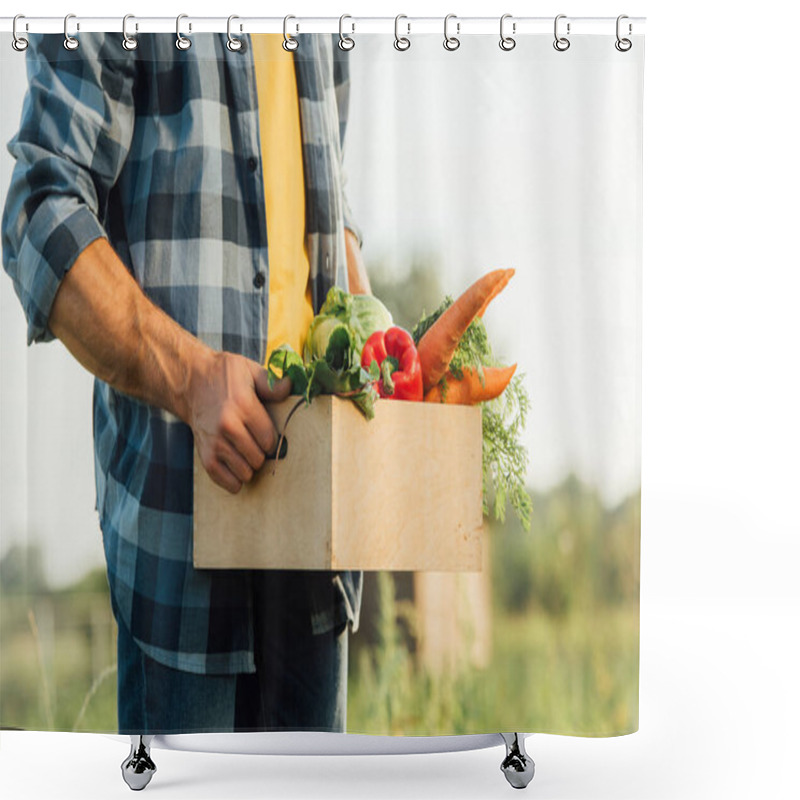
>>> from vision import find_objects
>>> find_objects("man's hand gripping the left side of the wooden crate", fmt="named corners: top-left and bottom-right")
top-left (187, 351), bottom-right (291, 494)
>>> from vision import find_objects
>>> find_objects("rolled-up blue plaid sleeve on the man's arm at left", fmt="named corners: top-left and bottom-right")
top-left (2, 33), bottom-right (136, 344)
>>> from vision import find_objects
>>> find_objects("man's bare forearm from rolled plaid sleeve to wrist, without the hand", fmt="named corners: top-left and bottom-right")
top-left (49, 239), bottom-right (213, 421)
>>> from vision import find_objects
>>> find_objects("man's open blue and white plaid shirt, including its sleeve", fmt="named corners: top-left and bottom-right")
top-left (2, 33), bottom-right (362, 673)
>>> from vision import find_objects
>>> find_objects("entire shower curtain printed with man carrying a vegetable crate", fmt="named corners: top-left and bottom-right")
top-left (0, 27), bottom-right (644, 736)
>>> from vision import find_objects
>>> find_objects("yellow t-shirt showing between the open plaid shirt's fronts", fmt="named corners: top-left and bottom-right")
top-left (250, 33), bottom-right (314, 358)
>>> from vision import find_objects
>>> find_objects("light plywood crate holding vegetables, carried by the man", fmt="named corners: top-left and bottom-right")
top-left (194, 396), bottom-right (483, 572)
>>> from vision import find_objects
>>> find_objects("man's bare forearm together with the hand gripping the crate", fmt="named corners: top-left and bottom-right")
top-left (49, 239), bottom-right (290, 492)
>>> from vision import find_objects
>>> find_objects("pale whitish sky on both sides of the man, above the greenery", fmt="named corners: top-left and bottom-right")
top-left (0, 35), bottom-right (642, 585)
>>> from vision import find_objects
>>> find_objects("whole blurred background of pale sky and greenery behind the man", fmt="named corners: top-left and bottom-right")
top-left (0, 36), bottom-right (642, 735)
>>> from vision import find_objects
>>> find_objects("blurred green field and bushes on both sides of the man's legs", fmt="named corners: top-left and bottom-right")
top-left (0, 478), bottom-right (639, 736)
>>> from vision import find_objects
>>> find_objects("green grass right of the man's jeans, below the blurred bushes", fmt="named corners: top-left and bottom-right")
top-left (347, 576), bottom-right (639, 736)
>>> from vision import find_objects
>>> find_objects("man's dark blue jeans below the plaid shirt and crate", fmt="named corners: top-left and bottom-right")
top-left (117, 570), bottom-right (347, 734)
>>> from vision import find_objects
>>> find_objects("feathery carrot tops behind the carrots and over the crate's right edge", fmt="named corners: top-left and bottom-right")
top-left (411, 296), bottom-right (533, 530)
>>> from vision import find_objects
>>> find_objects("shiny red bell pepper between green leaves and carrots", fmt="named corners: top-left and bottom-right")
top-left (361, 327), bottom-right (422, 401)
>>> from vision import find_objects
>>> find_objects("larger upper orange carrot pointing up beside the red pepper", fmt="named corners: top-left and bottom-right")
top-left (417, 269), bottom-right (514, 392)
